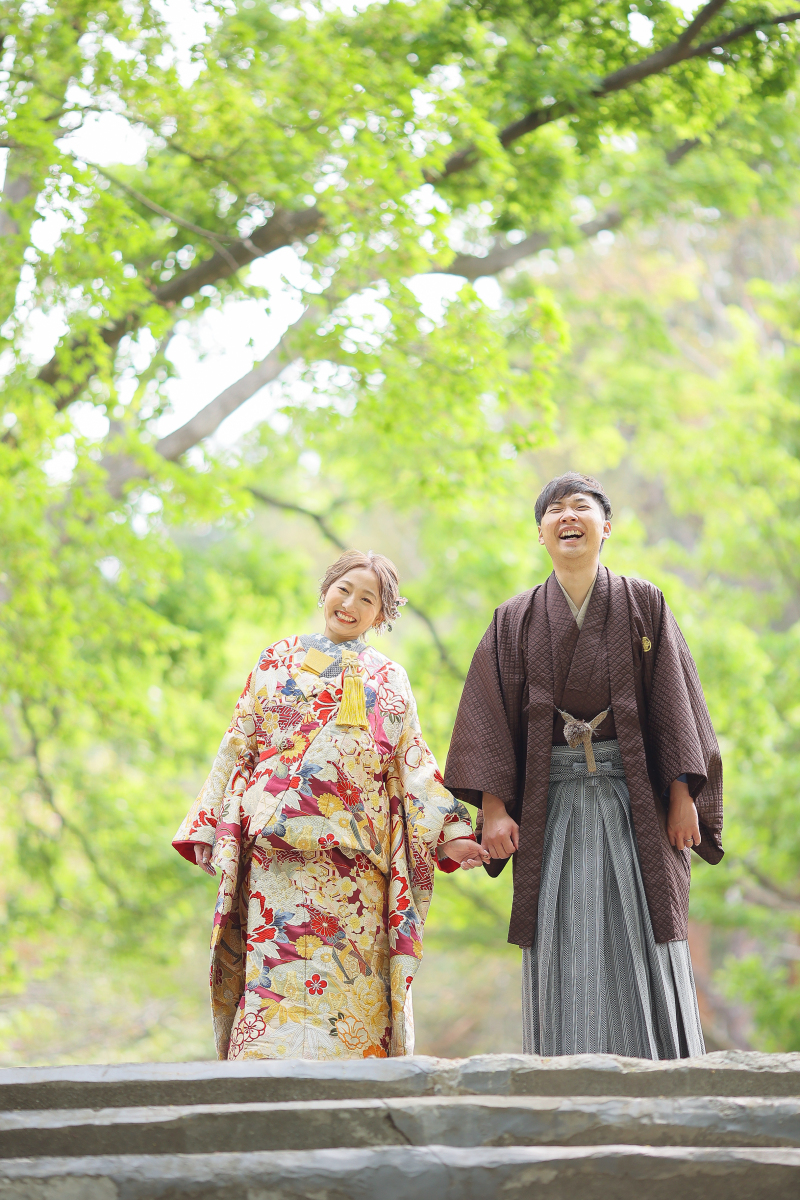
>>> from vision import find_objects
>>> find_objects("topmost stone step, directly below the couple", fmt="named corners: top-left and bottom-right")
top-left (0, 1050), bottom-right (800, 1111)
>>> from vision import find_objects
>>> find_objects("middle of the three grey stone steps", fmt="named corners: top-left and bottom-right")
top-left (0, 1096), bottom-right (800, 1159)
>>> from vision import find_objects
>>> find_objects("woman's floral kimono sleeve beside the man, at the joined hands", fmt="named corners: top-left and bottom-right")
top-left (387, 689), bottom-right (475, 872)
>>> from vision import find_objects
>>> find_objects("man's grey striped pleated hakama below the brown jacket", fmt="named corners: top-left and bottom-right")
top-left (522, 740), bottom-right (705, 1058)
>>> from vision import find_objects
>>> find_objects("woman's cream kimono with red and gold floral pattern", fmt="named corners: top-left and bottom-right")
top-left (173, 635), bottom-right (473, 1060)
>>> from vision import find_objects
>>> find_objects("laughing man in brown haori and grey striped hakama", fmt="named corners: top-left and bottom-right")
top-left (445, 473), bottom-right (722, 1058)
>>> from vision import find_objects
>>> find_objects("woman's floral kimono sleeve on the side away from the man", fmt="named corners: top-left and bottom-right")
top-left (173, 671), bottom-right (258, 863)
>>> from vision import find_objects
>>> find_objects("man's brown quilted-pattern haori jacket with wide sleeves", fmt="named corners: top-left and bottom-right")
top-left (445, 565), bottom-right (723, 946)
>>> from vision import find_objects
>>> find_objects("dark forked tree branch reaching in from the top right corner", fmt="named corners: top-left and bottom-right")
top-left (438, 0), bottom-right (800, 182)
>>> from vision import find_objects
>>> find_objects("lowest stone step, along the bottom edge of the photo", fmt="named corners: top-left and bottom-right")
top-left (0, 1146), bottom-right (800, 1200)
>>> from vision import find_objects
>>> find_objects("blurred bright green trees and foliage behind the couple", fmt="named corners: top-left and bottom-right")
top-left (0, 0), bottom-right (800, 1064)
